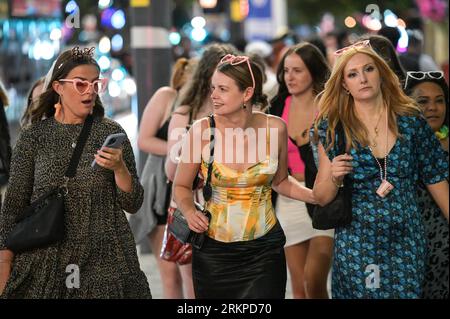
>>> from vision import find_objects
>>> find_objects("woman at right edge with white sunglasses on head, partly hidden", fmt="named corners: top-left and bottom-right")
top-left (406, 71), bottom-right (449, 299)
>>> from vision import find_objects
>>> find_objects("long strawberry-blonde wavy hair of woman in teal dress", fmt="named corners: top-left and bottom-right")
top-left (314, 47), bottom-right (421, 152)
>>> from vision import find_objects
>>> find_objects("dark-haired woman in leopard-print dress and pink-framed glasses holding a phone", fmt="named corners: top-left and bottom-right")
top-left (0, 49), bottom-right (151, 298)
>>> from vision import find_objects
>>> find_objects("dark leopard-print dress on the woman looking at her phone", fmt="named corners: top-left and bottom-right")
top-left (0, 117), bottom-right (151, 298)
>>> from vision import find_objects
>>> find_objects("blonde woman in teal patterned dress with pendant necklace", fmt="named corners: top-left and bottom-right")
top-left (313, 41), bottom-right (449, 299)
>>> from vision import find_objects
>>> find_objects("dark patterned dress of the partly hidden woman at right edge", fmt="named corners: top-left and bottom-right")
top-left (418, 150), bottom-right (449, 299)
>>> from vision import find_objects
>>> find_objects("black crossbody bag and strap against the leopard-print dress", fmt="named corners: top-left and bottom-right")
top-left (5, 116), bottom-right (93, 253)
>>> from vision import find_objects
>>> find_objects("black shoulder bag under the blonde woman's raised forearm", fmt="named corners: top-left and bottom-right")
top-left (312, 122), bottom-right (352, 230)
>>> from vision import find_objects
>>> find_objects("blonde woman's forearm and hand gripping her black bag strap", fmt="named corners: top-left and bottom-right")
top-left (313, 143), bottom-right (352, 206)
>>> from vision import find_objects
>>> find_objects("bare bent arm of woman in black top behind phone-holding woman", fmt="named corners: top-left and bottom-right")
top-left (138, 87), bottom-right (177, 156)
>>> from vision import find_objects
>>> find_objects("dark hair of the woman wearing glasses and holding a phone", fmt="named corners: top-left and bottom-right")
top-left (31, 50), bottom-right (105, 123)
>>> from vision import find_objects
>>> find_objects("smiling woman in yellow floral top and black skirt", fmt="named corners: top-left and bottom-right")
top-left (174, 55), bottom-right (315, 298)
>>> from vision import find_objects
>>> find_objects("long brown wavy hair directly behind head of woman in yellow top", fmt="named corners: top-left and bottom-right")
top-left (181, 43), bottom-right (237, 119)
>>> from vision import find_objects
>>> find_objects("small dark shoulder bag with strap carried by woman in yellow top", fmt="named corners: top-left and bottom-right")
top-left (168, 115), bottom-right (216, 249)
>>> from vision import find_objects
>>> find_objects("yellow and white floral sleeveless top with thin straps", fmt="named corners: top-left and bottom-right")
top-left (201, 117), bottom-right (278, 242)
